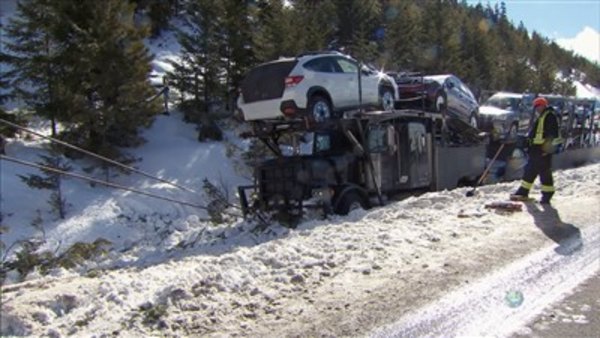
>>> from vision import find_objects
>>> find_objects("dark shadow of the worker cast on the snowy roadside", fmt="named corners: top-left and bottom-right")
top-left (525, 203), bottom-right (583, 256)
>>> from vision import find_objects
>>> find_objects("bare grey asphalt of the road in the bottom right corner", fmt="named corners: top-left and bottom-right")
top-left (512, 272), bottom-right (600, 338)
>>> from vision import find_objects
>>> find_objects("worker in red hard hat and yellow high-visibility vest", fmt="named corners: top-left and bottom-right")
top-left (510, 97), bottom-right (562, 204)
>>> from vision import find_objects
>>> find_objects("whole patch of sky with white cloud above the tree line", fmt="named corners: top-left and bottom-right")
top-left (467, 0), bottom-right (600, 64)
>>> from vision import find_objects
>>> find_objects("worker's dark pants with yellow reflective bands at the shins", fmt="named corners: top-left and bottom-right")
top-left (517, 146), bottom-right (554, 201)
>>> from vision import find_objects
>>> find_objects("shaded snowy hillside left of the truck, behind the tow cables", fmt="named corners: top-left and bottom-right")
top-left (0, 113), bottom-right (248, 266)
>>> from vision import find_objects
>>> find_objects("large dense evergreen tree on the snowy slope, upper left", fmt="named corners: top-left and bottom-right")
top-left (56, 0), bottom-right (159, 155)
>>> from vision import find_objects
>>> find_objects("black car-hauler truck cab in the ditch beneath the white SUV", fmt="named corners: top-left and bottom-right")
top-left (238, 110), bottom-right (486, 215)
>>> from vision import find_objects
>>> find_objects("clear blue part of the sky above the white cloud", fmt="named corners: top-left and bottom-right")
top-left (467, 0), bottom-right (600, 39)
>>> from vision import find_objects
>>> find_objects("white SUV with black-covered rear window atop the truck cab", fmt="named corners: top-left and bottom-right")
top-left (238, 52), bottom-right (396, 122)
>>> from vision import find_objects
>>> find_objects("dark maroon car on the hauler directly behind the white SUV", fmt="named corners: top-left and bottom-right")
top-left (389, 73), bottom-right (479, 128)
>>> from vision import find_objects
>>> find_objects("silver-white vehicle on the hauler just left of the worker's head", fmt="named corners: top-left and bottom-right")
top-left (479, 92), bottom-right (533, 139)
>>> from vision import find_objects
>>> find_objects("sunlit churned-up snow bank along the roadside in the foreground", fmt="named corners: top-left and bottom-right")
top-left (2, 164), bottom-right (600, 337)
